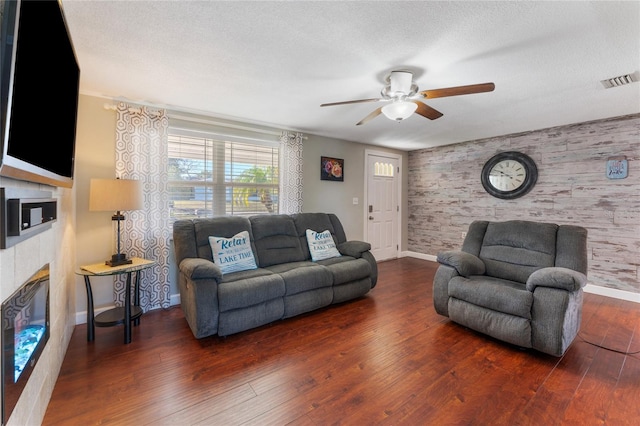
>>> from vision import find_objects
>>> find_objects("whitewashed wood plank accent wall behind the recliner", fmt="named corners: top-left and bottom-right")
top-left (408, 114), bottom-right (640, 293)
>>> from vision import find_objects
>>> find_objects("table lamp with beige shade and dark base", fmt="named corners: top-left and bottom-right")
top-left (89, 179), bottom-right (143, 266)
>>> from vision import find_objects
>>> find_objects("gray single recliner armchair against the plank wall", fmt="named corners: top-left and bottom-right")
top-left (433, 220), bottom-right (587, 356)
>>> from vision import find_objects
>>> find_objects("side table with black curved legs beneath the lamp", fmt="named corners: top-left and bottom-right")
top-left (76, 257), bottom-right (156, 344)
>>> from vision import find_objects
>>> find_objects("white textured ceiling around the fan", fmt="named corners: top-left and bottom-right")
top-left (63, 0), bottom-right (640, 150)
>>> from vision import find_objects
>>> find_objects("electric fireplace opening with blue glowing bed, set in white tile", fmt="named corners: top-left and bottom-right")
top-left (1, 264), bottom-right (49, 425)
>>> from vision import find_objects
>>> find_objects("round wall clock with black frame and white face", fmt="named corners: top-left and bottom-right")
top-left (481, 151), bottom-right (538, 200)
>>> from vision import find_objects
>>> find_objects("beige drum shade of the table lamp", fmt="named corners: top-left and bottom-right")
top-left (89, 179), bottom-right (143, 212)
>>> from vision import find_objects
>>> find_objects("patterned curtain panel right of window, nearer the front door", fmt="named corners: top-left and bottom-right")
top-left (278, 132), bottom-right (304, 214)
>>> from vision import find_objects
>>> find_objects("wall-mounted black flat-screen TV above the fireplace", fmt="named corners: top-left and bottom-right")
top-left (0, 0), bottom-right (80, 187)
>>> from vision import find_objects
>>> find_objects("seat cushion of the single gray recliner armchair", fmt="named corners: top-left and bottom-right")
top-left (449, 275), bottom-right (533, 319)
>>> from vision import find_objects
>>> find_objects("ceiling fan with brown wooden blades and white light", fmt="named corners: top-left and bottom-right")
top-left (320, 71), bottom-right (495, 126)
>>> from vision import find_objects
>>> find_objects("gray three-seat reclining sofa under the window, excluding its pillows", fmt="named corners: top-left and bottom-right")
top-left (173, 213), bottom-right (378, 338)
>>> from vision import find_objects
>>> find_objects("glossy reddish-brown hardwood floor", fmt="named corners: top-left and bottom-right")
top-left (43, 258), bottom-right (640, 426)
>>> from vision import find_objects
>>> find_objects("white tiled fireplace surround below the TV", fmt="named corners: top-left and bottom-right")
top-left (0, 182), bottom-right (76, 425)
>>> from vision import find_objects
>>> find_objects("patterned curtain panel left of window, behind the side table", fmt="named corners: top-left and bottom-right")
top-left (114, 102), bottom-right (171, 312)
